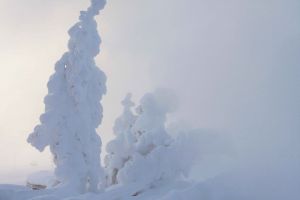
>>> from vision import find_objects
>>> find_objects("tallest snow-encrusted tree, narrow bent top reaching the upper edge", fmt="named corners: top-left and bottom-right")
top-left (28, 0), bottom-right (106, 192)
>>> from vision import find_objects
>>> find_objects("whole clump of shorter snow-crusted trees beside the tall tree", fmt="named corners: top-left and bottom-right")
top-left (105, 89), bottom-right (195, 188)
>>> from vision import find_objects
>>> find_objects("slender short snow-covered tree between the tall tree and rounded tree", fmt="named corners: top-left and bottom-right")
top-left (105, 94), bottom-right (136, 186)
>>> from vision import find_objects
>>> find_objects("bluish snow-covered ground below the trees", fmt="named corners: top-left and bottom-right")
top-left (0, 167), bottom-right (300, 200)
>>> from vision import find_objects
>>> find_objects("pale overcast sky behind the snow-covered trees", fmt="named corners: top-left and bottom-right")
top-left (0, 0), bottom-right (300, 195)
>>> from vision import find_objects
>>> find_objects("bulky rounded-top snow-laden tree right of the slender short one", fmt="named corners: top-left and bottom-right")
top-left (117, 89), bottom-right (183, 185)
